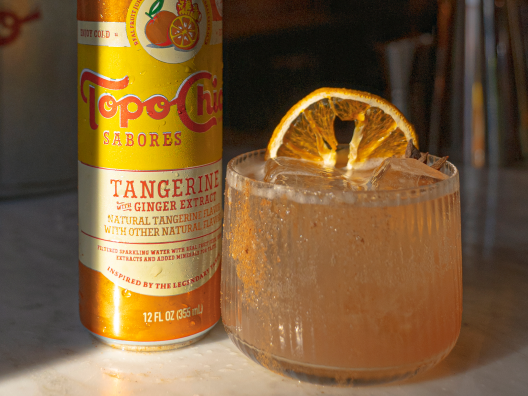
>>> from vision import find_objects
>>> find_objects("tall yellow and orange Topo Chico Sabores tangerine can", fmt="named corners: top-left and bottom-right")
top-left (77, 0), bottom-right (222, 351)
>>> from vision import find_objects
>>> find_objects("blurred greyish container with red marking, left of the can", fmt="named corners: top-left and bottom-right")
top-left (0, 0), bottom-right (77, 199)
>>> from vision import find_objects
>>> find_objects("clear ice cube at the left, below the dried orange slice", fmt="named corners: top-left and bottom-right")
top-left (264, 157), bottom-right (356, 190)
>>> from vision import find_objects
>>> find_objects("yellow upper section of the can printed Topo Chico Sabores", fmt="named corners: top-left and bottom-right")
top-left (78, 0), bottom-right (223, 170)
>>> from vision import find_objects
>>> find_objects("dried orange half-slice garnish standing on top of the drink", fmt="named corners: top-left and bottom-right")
top-left (266, 88), bottom-right (418, 169)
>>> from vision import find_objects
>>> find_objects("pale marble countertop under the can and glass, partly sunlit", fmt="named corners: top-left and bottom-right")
top-left (0, 155), bottom-right (528, 396)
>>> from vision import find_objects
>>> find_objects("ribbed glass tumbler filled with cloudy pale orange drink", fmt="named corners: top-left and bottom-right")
top-left (222, 150), bottom-right (462, 385)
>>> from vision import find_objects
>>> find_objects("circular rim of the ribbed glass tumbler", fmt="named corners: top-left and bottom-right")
top-left (226, 149), bottom-right (459, 206)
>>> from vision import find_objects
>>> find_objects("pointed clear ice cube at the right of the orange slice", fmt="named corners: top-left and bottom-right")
top-left (371, 158), bottom-right (448, 190)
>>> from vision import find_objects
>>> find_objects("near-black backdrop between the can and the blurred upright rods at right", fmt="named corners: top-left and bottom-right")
top-left (223, 0), bottom-right (437, 149)
